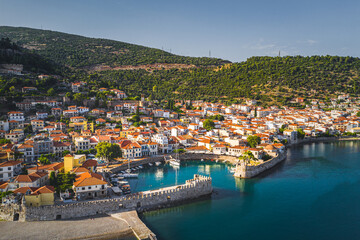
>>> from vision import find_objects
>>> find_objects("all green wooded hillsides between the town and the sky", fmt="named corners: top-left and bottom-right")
top-left (0, 27), bottom-right (360, 105)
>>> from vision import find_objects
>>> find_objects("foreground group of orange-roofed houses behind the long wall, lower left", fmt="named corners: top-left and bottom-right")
top-left (0, 154), bottom-right (101, 207)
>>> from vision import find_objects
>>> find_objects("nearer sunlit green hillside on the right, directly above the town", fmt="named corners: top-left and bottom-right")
top-left (73, 56), bottom-right (360, 104)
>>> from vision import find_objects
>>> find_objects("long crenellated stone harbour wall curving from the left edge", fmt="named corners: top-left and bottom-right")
top-left (0, 175), bottom-right (212, 221)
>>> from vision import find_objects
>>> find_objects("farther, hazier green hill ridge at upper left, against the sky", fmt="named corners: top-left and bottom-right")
top-left (0, 26), bottom-right (228, 69)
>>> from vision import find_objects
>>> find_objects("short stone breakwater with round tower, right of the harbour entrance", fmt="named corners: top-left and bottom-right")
top-left (234, 152), bottom-right (286, 178)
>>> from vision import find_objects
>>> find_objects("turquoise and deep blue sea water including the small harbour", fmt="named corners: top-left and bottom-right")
top-left (130, 142), bottom-right (360, 240)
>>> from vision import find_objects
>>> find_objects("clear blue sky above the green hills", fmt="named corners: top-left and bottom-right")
top-left (0, 0), bottom-right (360, 62)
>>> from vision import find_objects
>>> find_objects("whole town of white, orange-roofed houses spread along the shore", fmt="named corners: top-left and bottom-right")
top-left (0, 90), bottom-right (360, 206)
